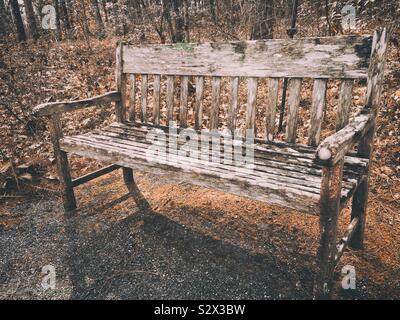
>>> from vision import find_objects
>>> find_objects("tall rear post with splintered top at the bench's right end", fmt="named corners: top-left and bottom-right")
top-left (349, 29), bottom-right (389, 249)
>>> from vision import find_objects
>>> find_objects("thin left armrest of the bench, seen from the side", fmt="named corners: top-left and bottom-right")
top-left (33, 91), bottom-right (121, 116)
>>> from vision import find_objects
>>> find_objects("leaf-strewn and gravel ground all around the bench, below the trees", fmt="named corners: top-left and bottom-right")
top-left (0, 25), bottom-right (400, 299)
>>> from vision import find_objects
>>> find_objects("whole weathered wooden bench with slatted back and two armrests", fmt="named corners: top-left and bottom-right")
top-left (34, 30), bottom-right (387, 298)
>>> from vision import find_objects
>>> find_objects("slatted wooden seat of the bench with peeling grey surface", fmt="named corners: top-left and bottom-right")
top-left (60, 122), bottom-right (368, 214)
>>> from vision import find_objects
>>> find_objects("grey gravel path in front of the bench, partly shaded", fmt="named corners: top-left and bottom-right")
top-left (0, 171), bottom-right (388, 299)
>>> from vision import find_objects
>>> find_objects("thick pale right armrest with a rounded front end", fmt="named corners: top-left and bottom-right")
top-left (315, 113), bottom-right (375, 167)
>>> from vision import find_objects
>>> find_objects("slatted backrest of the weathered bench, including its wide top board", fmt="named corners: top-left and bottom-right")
top-left (117, 36), bottom-right (373, 146)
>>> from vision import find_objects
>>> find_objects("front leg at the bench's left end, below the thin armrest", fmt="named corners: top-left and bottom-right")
top-left (50, 113), bottom-right (76, 212)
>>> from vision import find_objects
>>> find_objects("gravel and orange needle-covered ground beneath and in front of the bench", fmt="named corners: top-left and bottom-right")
top-left (0, 171), bottom-right (400, 299)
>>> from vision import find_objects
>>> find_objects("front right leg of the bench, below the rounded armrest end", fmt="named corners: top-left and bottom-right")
top-left (314, 161), bottom-right (343, 299)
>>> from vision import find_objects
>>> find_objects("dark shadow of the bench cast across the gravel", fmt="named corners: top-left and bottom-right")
top-left (65, 185), bottom-right (313, 299)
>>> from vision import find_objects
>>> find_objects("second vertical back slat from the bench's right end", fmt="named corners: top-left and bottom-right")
top-left (308, 79), bottom-right (327, 147)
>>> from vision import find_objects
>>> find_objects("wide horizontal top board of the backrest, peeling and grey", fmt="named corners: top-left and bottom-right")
top-left (124, 36), bottom-right (372, 78)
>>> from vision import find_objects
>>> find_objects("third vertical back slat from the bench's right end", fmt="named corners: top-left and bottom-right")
top-left (286, 78), bottom-right (302, 143)
